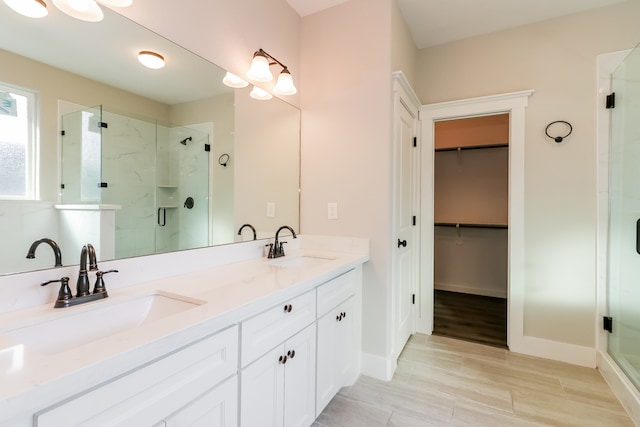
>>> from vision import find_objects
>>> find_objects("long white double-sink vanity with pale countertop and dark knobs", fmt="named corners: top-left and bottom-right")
top-left (0, 235), bottom-right (369, 427)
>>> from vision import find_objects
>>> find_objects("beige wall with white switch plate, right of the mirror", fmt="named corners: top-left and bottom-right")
top-left (301, 0), bottom-right (392, 357)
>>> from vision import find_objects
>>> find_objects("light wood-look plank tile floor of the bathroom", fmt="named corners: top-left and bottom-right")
top-left (313, 334), bottom-right (634, 427)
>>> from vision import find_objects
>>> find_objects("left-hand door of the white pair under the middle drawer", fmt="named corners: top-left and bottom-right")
top-left (240, 345), bottom-right (285, 427)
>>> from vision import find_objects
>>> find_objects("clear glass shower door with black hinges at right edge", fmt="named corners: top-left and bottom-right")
top-left (608, 41), bottom-right (640, 389)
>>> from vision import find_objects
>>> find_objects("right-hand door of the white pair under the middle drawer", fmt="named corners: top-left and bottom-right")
top-left (284, 325), bottom-right (316, 427)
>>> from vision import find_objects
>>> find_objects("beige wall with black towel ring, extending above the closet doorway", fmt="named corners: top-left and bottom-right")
top-left (415, 1), bottom-right (640, 347)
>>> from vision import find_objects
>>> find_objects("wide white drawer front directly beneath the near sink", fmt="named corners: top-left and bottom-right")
top-left (35, 326), bottom-right (238, 427)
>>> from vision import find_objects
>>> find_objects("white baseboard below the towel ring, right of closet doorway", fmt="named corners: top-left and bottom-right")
top-left (509, 336), bottom-right (596, 368)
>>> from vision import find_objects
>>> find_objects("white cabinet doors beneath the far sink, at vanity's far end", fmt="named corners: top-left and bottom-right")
top-left (316, 297), bottom-right (357, 416)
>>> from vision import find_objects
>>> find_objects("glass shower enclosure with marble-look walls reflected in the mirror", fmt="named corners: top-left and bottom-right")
top-left (61, 106), bottom-right (209, 258)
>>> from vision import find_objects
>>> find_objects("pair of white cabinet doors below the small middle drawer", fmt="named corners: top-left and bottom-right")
top-left (240, 324), bottom-right (316, 427)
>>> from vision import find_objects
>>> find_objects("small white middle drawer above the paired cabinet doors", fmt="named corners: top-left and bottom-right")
top-left (241, 290), bottom-right (316, 367)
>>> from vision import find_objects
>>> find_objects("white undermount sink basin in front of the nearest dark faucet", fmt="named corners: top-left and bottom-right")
top-left (2, 292), bottom-right (204, 354)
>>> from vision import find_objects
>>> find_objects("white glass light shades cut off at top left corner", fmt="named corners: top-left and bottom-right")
top-left (4, 0), bottom-right (133, 22)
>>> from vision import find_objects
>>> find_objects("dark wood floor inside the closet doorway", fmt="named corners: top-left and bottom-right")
top-left (433, 290), bottom-right (507, 348)
